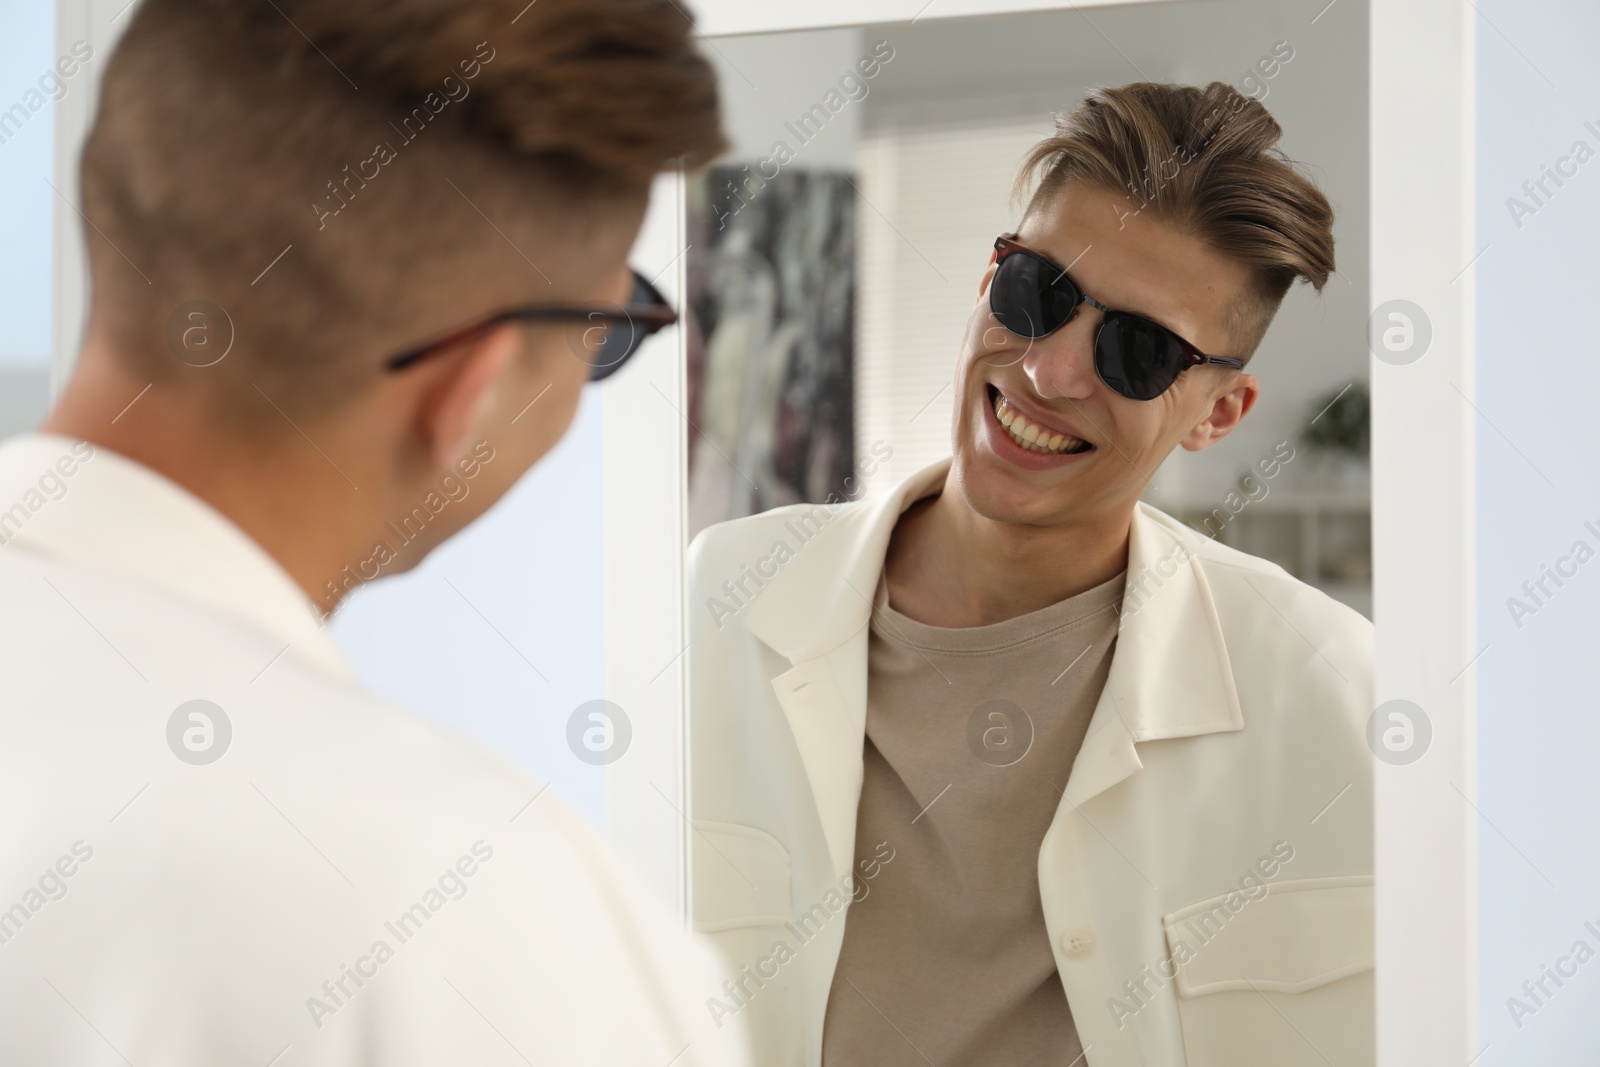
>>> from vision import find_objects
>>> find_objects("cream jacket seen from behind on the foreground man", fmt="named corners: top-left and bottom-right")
top-left (0, 435), bottom-right (749, 1067)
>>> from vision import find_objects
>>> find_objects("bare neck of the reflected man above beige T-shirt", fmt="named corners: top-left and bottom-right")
top-left (885, 485), bottom-right (1133, 627)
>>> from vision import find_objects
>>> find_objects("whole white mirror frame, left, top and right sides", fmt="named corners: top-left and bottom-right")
top-left (605, 0), bottom-right (1480, 1067)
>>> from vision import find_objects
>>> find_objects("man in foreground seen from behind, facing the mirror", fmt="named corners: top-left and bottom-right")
top-left (0, 0), bottom-right (747, 1067)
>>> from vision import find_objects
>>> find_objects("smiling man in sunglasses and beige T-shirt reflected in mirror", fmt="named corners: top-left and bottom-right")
top-left (690, 83), bottom-right (1374, 1067)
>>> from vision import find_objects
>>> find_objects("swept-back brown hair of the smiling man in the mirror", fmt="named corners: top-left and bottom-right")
top-left (1014, 82), bottom-right (1334, 358)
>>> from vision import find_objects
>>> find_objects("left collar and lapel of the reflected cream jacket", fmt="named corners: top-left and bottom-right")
top-left (744, 458), bottom-right (950, 877)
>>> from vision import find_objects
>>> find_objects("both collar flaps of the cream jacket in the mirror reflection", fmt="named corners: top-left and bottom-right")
top-left (744, 458), bottom-right (1245, 777)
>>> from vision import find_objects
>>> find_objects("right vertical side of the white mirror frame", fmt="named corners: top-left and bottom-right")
top-left (1368, 0), bottom-right (1482, 1067)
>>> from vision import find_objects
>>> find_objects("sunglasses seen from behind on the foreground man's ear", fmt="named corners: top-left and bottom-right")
top-left (384, 270), bottom-right (678, 382)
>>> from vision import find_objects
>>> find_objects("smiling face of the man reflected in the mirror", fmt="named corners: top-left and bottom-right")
top-left (950, 182), bottom-right (1256, 526)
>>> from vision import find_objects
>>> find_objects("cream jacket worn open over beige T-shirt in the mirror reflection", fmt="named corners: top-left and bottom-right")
top-left (690, 459), bottom-right (1374, 1067)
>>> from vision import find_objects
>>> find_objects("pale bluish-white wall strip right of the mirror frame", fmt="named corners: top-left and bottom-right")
top-left (1456, 0), bottom-right (1600, 1067)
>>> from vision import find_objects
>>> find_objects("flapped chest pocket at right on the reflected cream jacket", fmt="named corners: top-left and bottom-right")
top-left (1162, 875), bottom-right (1376, 1067)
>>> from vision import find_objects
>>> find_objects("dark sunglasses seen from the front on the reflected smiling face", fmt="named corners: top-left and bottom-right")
top-left (989, 237), bottom-right (1245, 400)
